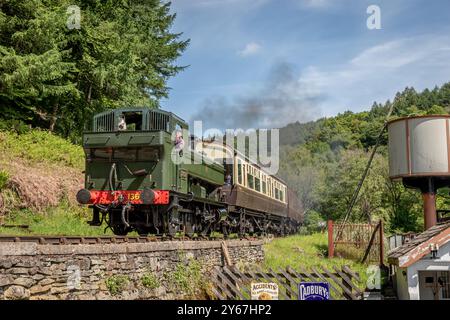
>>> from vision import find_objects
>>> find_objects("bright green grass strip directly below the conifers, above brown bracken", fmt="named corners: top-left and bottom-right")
top-left (0, 129), bottom-right (84, 169)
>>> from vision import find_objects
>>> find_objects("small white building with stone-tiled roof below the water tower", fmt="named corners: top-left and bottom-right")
top-left (389, 222), bottom-right (450, 300)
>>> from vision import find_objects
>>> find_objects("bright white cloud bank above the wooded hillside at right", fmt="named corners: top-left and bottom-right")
top-left (300, 36), bottom-right (450, 116)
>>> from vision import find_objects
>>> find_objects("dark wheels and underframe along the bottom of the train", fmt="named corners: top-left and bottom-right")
top-left (90, 193), bottom-right (299, 237)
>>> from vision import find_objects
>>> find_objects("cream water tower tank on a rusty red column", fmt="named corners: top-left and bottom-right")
top-left (388, 115), bottom-right (450, 229)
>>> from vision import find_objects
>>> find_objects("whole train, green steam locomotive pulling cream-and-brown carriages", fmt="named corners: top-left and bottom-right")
top-left (77, 108), bottom-right (303, 236)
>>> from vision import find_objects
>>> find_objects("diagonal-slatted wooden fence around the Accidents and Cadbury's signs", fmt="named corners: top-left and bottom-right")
top-left (211, 266), bottom-right (363, 300)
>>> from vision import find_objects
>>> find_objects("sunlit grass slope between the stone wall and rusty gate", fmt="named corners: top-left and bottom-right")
top-left (264, 233), bottom-right (367, 288)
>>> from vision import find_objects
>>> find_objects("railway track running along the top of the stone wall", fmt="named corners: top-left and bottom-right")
top-left (0, 236), bottom-right (261, 245)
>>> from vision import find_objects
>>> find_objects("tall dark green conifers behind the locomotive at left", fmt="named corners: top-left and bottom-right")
top-left (0, 0), bottom-right (189, 141)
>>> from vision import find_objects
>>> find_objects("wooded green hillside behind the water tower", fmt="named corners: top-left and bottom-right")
top-left (280, 83), bottom-right (450, 231)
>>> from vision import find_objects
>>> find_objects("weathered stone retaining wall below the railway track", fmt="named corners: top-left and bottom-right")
top-left (0, 240), bottom-right (264, 299)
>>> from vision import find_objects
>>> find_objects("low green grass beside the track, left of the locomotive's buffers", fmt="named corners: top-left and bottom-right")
top-left (0, 202), bottom-right (112, 236)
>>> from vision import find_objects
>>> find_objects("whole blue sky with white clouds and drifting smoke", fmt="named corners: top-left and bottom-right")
top-left (161, 0), bottom-right (450, 130)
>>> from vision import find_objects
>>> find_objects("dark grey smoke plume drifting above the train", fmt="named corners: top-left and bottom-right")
top-left (190, 63), bottom-right (325, 129)
